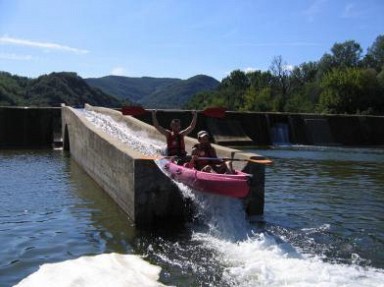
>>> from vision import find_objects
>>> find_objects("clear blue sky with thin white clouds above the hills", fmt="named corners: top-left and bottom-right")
top-left (0, 0), bottom-right (384, 81)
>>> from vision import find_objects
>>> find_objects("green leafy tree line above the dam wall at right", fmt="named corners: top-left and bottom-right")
top-left (186, 35), bottom-right (384, 115)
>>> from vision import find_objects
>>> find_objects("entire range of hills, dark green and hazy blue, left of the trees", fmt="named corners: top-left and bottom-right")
top-left (0, 71), bottom-right (220, 108)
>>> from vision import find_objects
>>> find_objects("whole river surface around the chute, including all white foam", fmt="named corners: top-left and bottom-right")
top-left (0, 110), bottom-right (384, 286)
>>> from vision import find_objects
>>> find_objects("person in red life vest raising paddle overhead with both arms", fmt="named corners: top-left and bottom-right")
top-left (152, 110), bottom-right (197, 161)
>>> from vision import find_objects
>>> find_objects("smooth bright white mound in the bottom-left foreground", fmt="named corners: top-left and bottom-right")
top-left (15, 253), bottom-right (166, 287)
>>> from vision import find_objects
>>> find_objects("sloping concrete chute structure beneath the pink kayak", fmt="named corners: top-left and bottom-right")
top-left (62, 105), bottom-right (265, 226)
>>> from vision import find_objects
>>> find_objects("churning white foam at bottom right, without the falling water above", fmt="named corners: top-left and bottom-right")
top-left (195, 234), bottom-right (384, 287)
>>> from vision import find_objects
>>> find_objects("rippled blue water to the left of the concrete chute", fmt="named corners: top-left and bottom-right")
top-left (0, 150), bottom-right (132, 286)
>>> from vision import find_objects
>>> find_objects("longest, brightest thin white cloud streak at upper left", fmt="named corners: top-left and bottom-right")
top-left (0, 36), bottom-right (89, 54)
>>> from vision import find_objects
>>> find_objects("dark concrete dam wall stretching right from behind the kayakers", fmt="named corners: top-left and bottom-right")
top-left (133, 110), bottom-right (384, 146)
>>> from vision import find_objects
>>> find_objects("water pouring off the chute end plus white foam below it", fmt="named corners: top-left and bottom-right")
top-left (192, 197), bottom-right (384, 287)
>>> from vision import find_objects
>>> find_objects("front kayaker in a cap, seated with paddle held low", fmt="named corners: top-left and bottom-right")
top-left (187, 131), bottom-right (233, 173)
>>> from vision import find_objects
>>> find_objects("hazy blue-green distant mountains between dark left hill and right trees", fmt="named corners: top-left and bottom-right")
top-left (85, 75), bottom-right (220, 108)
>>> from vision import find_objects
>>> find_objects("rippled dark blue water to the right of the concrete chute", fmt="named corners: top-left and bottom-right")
top-left (250, 147), bottom-right (384, 268)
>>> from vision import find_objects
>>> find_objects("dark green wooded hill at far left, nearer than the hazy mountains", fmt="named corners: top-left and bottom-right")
top-left (0, 72), bottom-right (122, 107)
